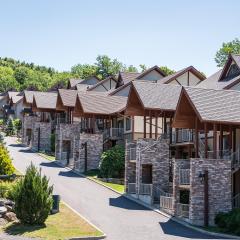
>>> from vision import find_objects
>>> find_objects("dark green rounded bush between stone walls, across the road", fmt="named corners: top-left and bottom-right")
top-left (100, 145), bottom-right (125, 178)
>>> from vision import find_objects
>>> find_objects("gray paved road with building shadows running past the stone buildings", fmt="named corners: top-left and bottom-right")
top-left (3, 138), bottom-right (224, 240)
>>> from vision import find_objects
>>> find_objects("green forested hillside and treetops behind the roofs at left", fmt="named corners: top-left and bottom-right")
top-left (0, 55), bottom-right (173, 92)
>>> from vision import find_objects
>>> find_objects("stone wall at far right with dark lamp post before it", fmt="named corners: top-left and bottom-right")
top-left (189, 159), bottom-right (232, 225)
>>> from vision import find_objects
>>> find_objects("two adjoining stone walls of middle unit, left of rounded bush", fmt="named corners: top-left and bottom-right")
top-left (55, 123), bottom-right (103, 172)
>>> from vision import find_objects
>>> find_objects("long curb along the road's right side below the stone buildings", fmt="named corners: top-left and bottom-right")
top-left (31, 150), bottom-right (240, 240)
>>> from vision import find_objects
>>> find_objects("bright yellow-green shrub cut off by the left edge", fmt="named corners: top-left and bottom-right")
top-left (0, 144), bottom-right (15, 175)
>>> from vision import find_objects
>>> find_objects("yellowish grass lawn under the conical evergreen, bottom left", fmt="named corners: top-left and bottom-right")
top-left (2, 203), bottom-right (103, 240)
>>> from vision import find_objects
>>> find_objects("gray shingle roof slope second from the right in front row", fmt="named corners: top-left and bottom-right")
top-left (132, 81), bottom-right (182, 111)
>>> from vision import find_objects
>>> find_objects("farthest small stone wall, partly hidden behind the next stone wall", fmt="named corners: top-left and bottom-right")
top-left (22, 115), bottom-right (40, 145)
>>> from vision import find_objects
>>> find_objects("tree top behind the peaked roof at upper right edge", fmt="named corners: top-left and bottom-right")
top-left (215, 38), bottom-right (240, 67)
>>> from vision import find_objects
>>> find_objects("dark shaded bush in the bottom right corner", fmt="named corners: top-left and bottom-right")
top-left (215, 208), bottom-right (240, 235)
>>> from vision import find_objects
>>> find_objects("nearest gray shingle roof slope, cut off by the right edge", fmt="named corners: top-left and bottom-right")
top-left (184, 87), bottom-right (240, 123)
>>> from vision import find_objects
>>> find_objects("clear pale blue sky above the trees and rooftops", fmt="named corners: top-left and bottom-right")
top-left (0, 0), bottom-right (240, 75)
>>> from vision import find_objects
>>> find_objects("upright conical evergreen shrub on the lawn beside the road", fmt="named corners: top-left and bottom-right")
top-left (12, 164), bottom-right (53, 225)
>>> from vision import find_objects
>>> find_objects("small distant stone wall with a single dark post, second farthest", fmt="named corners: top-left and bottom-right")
top-left (32, 122), bottom-right (52, 152)
